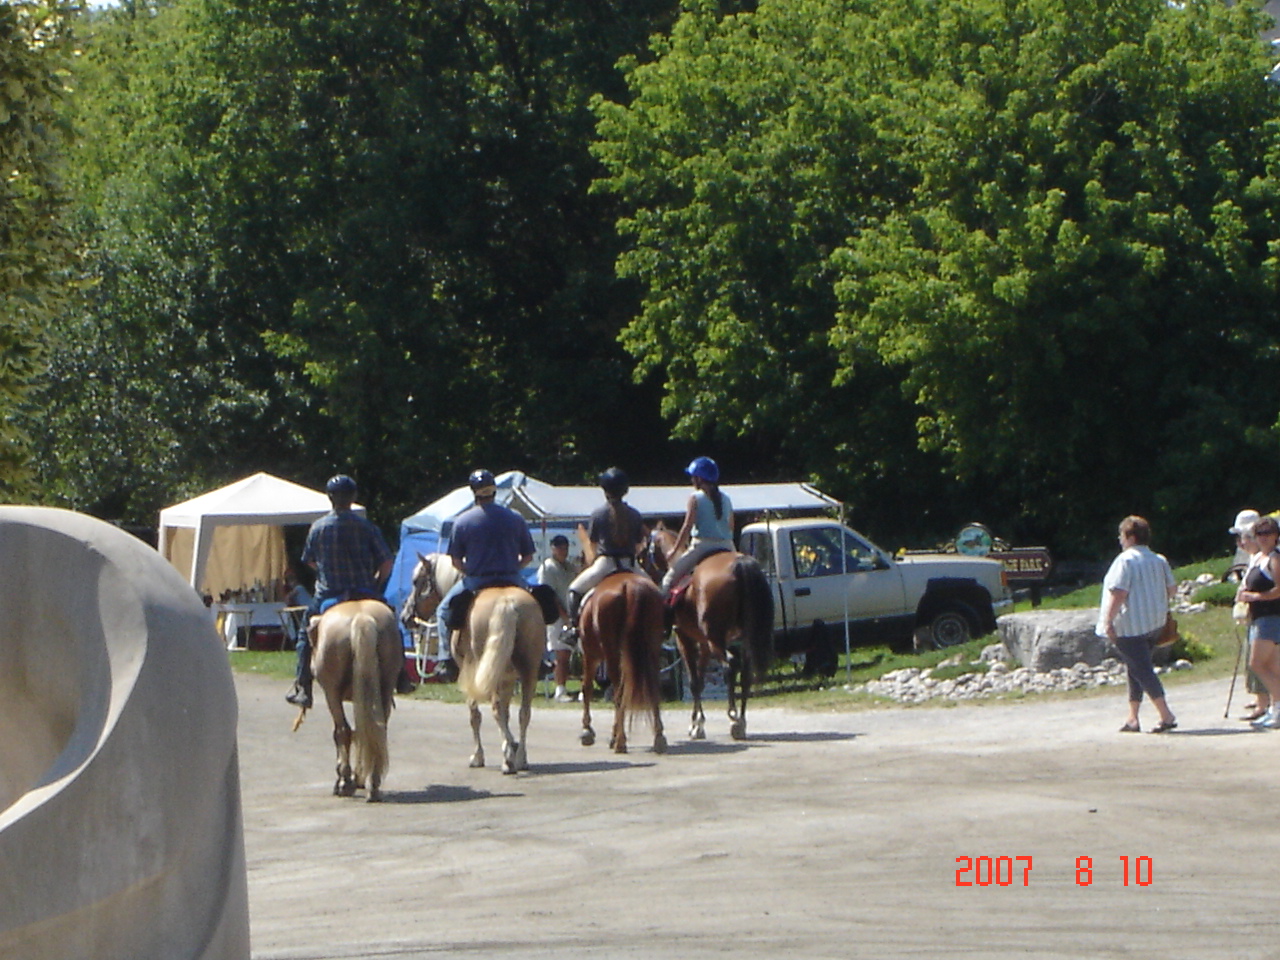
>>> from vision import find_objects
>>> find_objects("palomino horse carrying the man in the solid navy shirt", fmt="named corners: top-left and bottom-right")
top-left (406, 553), bottom-right (547, 773)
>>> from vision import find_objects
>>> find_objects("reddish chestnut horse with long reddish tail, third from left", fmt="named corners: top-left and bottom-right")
top-left (579, 571), bottom-right (667, 754)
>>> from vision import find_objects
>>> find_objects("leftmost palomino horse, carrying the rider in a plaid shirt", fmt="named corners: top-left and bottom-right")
top-left (293, 600), bottom-right (404, 803)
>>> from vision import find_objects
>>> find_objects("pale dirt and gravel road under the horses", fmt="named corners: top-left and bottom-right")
top-left (237, 675), bottom-right (1280, 960)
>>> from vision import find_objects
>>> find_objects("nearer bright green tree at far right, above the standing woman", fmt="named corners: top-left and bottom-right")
top-left (832, 0), bottom-right (1280, 548)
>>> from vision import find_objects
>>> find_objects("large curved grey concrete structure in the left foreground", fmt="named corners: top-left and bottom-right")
top-left (0, 507), bottom-right (248, 960)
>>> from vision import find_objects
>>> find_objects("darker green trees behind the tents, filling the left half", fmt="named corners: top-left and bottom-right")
top-left (32, 0), bottom-right (668, 527)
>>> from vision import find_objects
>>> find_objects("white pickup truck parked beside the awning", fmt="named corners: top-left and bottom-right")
top-left (739, 517), bottom-right (1009, 672)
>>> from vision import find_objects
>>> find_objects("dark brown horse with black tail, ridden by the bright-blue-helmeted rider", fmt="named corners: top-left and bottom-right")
top-left (649, 522), bottom-right (773, 740)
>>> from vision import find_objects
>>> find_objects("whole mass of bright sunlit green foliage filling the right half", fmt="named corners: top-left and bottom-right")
top-left (595, 0), bottom-right (1280, 547)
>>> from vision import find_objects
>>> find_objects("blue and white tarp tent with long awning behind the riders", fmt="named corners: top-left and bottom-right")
top-left (387, 470), bottom-right (840, 642)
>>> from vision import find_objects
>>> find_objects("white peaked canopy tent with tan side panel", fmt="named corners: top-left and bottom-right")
top-left (159, 474), bottom-right (365, 599)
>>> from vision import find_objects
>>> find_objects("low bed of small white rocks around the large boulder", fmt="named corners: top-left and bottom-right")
top-left (846, 644), bottom-right (1192, 703)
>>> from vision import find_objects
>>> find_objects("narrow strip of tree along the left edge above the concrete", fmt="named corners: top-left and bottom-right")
top-left (0, 3), bottom-right (77, 499)
